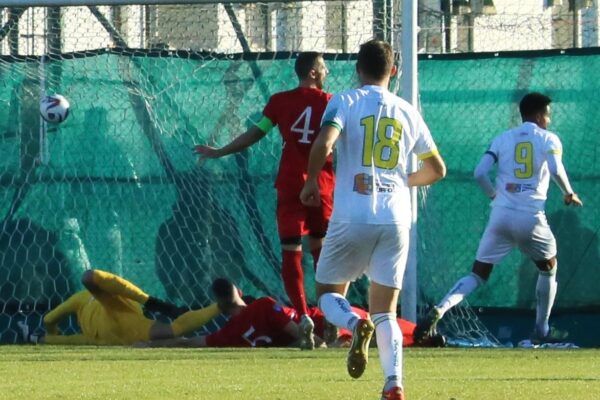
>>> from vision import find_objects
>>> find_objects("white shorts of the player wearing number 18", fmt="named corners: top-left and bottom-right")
top-left (316, 222), bottom-right (409, 289)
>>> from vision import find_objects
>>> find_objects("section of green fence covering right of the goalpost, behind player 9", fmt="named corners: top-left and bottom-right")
top-left (419, 51), bottom-right (600, 309)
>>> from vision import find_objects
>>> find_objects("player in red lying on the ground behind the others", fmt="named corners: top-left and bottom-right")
top-left (136, 279), bottom-right (445, 349)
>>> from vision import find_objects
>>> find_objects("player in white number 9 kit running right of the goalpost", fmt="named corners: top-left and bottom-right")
top-left (417, 92), bottom-right (583, 344)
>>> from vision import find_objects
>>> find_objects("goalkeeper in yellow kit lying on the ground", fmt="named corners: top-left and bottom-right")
top-left (19, 270), bottom-right (224, 345)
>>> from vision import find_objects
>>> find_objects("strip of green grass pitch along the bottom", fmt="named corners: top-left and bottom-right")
top-left (0, 346), bottom-right (600, 400)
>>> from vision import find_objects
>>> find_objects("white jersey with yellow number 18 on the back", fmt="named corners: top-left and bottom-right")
top-left (322, 86), bottom-right (437, 227)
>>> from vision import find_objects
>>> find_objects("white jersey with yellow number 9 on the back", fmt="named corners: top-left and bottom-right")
top-left (487, 122), bottom-right (562, 212)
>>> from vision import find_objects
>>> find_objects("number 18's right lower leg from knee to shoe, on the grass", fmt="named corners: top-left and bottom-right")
top-left (369, 282), bottom-right (404, 400)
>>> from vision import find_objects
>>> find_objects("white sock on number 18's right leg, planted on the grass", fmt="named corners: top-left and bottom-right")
top-left (371, 312), bottom-right (403, 390)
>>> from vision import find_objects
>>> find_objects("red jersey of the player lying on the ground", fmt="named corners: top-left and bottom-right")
top-left (206, 297), bottom-right (293, 347)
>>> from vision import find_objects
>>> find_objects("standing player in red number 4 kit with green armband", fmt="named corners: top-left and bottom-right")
top-left (195, 52), bottom-right (335, 349)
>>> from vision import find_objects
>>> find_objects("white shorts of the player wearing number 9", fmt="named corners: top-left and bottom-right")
top-left (475, 207), bottom-right (556, 264)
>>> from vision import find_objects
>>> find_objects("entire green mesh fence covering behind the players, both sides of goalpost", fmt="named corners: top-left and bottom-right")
top-left (0, 49), bottom-right (600, 340)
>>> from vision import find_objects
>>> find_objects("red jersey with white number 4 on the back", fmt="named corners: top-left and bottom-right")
top-left (263, 87), bottom-right (335, 194)
